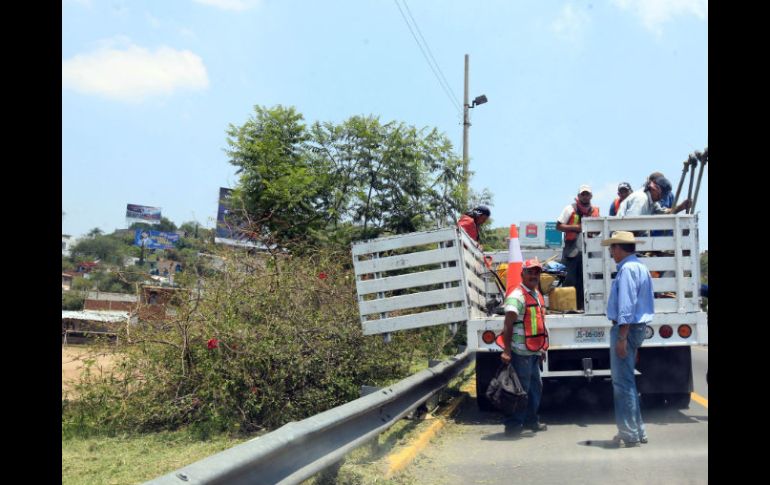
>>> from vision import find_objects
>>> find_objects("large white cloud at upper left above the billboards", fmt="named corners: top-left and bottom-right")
top-left (62, 39), bottom-right (209, 101)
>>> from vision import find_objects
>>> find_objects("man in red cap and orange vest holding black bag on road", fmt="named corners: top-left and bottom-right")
top-left (500, 258), bottom-right (548, 436)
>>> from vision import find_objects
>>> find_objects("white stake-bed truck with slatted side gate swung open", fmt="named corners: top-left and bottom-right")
top-left (352, 214), bottom-right (708, 410)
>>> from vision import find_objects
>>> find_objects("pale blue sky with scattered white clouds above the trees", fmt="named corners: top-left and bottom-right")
top-left (62, 0), bottom-right (708, 250)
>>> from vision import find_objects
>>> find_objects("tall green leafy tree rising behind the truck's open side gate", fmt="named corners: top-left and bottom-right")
top-left (227, 106), bottom-right (461, 244)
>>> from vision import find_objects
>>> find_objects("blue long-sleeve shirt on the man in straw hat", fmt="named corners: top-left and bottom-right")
top-left (607, 254), bottom-right (655, 325)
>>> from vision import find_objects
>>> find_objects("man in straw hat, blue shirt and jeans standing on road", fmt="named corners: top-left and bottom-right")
top-left (602, 231), bottom-right (655, 448)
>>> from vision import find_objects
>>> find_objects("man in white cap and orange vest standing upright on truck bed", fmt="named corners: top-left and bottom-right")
top-left (556, 185), bottom-right (599, 310)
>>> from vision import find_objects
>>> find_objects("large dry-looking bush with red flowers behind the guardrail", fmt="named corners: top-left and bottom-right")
top-left (62, 244), bottom-right (456, 434)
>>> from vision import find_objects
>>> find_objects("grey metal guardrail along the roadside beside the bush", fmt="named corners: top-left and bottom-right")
top-left (145, 350), bottom-right (472, 485)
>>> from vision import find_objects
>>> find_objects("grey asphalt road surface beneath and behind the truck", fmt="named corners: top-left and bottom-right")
top-left (402, 347), bottom-right (708, 485)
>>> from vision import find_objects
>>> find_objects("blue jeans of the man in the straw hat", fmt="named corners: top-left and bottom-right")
top-left (610, 324), bottom-right (647, 442)
